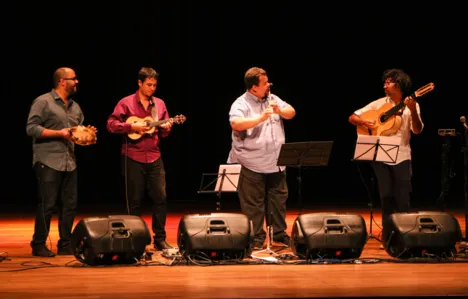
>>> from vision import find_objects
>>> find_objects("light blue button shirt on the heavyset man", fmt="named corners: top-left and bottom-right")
top-left (227, 92), bottom-right (289, 173)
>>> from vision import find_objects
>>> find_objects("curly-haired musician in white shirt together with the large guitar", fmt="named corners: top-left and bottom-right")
top-left (349, 69), bottom-right (426, 239)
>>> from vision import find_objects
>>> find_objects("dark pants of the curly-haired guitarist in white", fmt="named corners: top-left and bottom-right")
top-left (372, 160), bottom-right (412, 225)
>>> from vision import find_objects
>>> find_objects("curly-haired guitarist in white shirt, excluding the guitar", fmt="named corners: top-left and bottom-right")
top-left (348, 69), bottom-right (424, 239)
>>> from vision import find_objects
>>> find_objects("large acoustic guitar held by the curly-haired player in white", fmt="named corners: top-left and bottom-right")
top-left (357, 82), bottom-right (435, 136)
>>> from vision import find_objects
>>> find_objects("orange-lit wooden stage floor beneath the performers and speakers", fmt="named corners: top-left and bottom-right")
top-left (0, 204), bottom-right (468, 299)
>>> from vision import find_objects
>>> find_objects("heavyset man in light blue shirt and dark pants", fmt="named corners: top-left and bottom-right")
top-left (228, 67), bottom-right (296, 250)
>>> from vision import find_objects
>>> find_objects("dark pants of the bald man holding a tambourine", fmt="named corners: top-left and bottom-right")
top-left (31, 163), bottom-right (78, 247)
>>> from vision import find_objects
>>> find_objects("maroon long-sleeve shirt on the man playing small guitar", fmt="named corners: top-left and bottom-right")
top-left (107, 92), bottom-right (170, 163)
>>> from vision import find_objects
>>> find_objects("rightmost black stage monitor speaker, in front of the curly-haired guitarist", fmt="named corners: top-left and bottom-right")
top-left (382, 212), bottom-right (462, 259)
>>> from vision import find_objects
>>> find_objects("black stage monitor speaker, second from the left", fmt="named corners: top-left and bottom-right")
top-left (177, 213), bottom-right (253, 260)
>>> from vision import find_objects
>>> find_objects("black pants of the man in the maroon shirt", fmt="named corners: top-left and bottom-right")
top-left (122, 156), bottom-right (167, 242)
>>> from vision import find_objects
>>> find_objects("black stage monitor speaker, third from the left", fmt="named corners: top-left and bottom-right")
top-left (291, 213), bottom-right (367, 259)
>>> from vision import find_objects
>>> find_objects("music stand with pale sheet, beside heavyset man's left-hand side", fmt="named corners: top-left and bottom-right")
top-left (198, 164), bottom-right (241, 212)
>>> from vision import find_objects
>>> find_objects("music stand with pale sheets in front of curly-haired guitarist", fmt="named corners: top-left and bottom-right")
top-left (353, 135), bottom-right (401, 243)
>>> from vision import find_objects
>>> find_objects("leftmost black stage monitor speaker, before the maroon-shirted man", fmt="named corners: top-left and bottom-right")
top-left (71, 215), bottom-right (151, 265)
